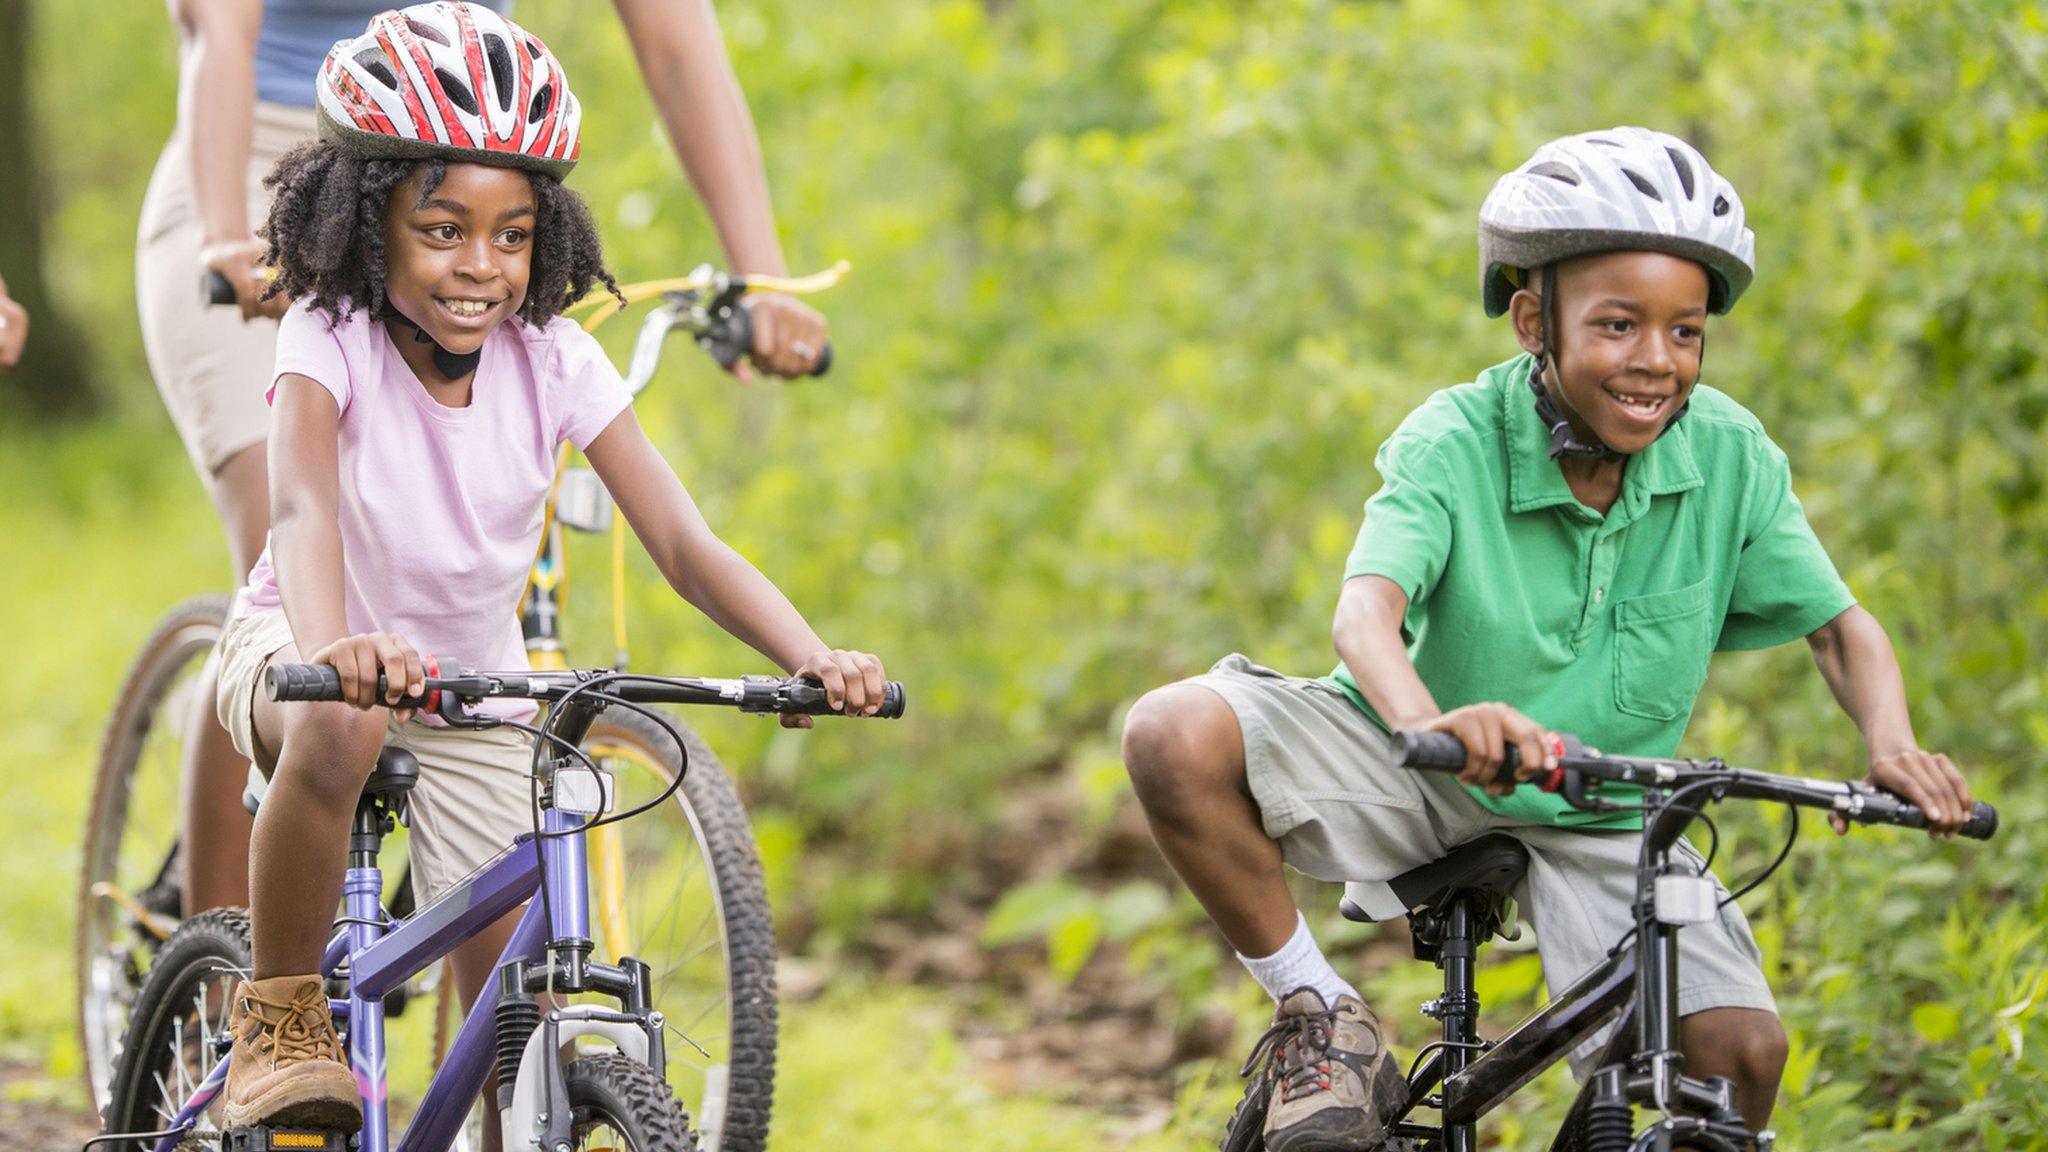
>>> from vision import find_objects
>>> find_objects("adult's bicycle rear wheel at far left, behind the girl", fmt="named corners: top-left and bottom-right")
top-left (72, 592), bottom-right (227, 1107)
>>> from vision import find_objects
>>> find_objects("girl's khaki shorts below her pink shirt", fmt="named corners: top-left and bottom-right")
top-left (215, 609), bottom-right (532, 904)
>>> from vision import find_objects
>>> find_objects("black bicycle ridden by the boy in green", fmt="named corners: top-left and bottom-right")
top-left (1223, 732), bottom-right (1999, 1152)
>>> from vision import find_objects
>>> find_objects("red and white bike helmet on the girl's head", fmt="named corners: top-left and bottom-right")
top-left (315, 0), bottom-right (582, 178)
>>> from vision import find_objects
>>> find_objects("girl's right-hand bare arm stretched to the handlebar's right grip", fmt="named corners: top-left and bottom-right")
top-left (584, 408), bottom-right (883, 719)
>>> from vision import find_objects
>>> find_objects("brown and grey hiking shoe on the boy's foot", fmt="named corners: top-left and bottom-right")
top-left (1241, 988), bottom-right (1407, 1152)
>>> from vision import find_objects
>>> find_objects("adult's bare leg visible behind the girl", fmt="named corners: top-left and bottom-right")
top-left (178, 441), bottom-right (270, 916)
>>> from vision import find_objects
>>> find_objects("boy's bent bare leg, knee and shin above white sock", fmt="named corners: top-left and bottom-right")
top-left (1124, 685), bottom-right (1298, 955)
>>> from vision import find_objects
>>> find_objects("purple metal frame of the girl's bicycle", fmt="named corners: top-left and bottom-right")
top-left (156, 701), bottom-right (630, 1152)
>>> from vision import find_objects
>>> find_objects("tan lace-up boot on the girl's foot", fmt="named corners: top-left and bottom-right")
top-left (223, 976), bottom-right (362, 1132)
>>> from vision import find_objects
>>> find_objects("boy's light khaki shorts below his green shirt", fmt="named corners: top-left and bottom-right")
top-left (1186, 656), bottom-right (1778, 1076)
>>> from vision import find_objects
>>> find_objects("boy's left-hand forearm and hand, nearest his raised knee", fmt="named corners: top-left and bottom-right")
top-left (1331, 576), bottom-right (1556, 795)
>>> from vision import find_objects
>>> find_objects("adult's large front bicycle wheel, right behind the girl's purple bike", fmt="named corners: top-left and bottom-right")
top-left (584, 707), bottom-right (778, 1152)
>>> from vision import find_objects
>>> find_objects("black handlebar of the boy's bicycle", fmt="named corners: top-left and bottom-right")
top-left (1395, 732), bottom-right (1999, 840)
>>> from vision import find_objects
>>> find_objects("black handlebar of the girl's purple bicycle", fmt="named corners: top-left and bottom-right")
top-left (264, 660), bottom-right (905, 719)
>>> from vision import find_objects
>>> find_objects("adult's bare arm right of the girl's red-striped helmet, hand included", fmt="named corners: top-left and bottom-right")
top-left (612, 0), bottom-right (825, 375)
